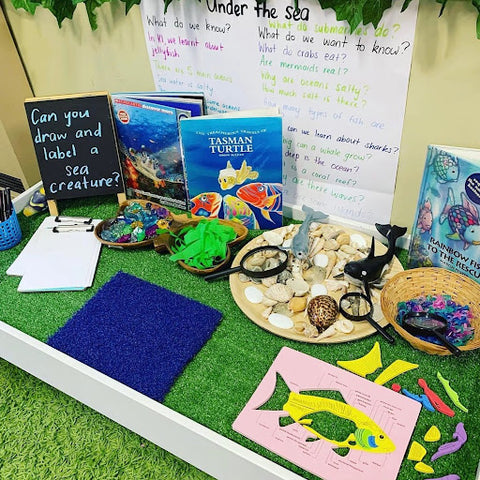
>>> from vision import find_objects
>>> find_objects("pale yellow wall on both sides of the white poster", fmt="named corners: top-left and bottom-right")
top-left (0, 0), bottom-right (480, 228)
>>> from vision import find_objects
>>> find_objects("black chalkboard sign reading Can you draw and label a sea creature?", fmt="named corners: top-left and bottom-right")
top-left (25, 92), bottom-right (124, 208)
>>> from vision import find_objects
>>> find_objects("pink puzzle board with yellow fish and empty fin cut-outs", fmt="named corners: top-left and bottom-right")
top-left (233, 347), bottom-right (422, 480)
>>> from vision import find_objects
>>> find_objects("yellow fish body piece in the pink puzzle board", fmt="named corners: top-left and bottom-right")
top-left (259, 372), bottom-right (396, 453)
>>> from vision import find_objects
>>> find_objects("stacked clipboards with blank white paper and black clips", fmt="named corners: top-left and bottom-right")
top-left (6, 216), bottom-right (102, 292)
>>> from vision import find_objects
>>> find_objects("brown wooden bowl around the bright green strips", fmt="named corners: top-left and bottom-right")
top-left (153, 217), bottom-right (248, 275)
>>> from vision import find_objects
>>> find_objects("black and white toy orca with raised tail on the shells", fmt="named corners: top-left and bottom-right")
top-left (344, 223), bottom-right (407, 286)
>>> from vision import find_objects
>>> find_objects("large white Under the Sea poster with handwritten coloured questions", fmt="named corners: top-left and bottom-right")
top-left (141, 0), bottom-right (418, 224)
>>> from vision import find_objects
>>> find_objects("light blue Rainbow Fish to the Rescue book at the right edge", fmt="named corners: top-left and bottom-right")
top-left (409, 145), bottom-right (480, 281)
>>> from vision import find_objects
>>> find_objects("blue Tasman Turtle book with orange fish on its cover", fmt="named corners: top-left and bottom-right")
top-left (180, 109), bottom-right (283, 229)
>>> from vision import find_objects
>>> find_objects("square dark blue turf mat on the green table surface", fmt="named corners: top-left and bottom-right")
top-left (47, 272), bottom-right (222, 401)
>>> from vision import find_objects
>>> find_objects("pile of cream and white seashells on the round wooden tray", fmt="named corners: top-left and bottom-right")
top-left (239, 223), bottom-right (394, 340)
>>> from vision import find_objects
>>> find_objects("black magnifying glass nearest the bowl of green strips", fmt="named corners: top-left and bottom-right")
top-left (204, 246), bottom-right (288, 282)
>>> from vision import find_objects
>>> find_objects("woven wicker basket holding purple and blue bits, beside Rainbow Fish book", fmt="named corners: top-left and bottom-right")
top-left (380, 267), bottom-right (480, 355)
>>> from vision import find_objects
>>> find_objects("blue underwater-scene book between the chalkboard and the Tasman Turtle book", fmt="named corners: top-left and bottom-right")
top-left (111, 94), bottom-right (196, 210)
